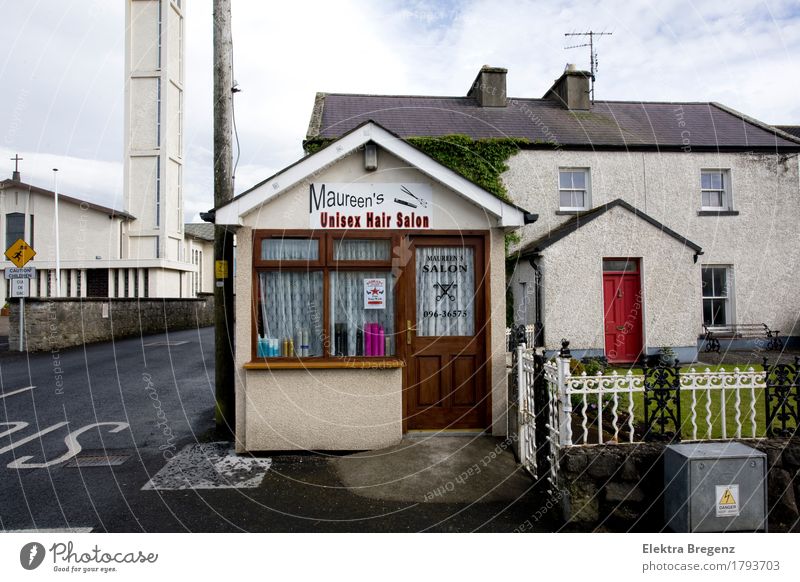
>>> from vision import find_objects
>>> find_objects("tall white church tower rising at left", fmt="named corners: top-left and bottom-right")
top-left (122, 0), bottom-right (187, 297)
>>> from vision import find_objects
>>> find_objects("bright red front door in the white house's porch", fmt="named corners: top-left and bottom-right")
top-left (603, 259), bottom-right (643, 363)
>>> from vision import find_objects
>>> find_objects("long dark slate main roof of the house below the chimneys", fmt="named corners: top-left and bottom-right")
top-left (307, 93), bottom-right (800, 151)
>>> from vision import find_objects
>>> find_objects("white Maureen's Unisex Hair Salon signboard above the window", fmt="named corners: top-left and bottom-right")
top-left (308, 182), bottom-right (433, 230)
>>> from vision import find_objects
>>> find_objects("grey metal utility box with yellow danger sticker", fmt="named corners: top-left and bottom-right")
top-left (664, 442), bottom-right (767, 533)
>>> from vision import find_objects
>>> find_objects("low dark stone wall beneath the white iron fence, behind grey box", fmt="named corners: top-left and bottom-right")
top-left (559, 439), bottom-right (800, 532)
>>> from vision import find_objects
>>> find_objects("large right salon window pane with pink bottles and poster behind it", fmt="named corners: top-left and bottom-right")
top-left (330, 271), bottom-right (397, 356)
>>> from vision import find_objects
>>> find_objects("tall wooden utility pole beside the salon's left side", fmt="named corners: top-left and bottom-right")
top-left (213, 0), bottom-right (236, 436)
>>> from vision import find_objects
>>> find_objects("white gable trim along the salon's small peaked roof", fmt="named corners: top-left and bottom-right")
top-left (214, 120), bottom-right (531, 227)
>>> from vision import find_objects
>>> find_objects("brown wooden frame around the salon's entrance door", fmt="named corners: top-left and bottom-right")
top-left (404, 230), bottom-right (494, 434)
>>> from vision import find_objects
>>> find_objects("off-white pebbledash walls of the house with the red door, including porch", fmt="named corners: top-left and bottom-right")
top-left (510, 150), bottom-right (800, 359)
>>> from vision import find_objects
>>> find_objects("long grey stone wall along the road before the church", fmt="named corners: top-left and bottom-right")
top-left (8, 294), bottom-right (214, 352)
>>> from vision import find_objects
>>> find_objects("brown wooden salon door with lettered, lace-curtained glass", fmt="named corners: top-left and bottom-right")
top-left (403, 236), bottom-right (490, 430)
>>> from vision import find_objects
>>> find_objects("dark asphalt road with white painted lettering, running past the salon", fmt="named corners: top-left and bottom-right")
top-left (0, 328), bottom-right (555, 532)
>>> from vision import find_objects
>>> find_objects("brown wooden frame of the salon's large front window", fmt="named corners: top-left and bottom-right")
top-left (250, 229), bottom-right (403, 366)
